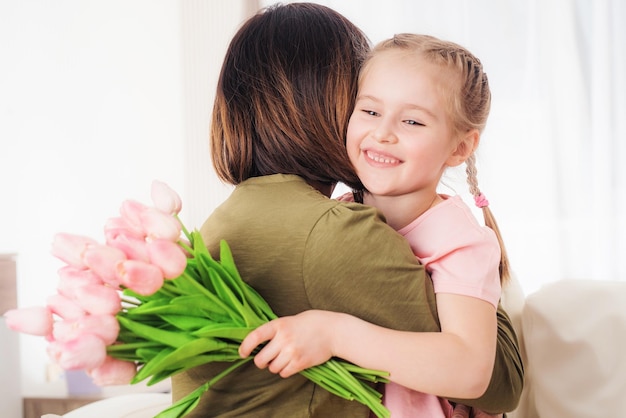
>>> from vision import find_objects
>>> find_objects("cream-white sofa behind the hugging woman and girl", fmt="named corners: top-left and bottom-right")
top-left (37, 280), bottom-right (626, 418)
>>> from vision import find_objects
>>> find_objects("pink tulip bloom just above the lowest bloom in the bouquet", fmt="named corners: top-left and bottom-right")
top-left (48, 334), bottom-right (106, 370)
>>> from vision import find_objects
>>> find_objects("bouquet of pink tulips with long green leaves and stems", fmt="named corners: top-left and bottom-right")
top-left (5, 181), bottom-right (389, 418)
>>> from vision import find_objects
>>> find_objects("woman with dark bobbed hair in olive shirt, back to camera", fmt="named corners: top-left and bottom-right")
top-left (173, 3), bottom-right (523, 417)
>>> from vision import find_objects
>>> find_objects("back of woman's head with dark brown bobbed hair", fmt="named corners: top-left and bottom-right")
top-left (211, 3), bottom-right (369, 187)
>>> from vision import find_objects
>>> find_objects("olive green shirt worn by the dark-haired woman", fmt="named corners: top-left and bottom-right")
top-left (172, 175), bottom-right (523, 418)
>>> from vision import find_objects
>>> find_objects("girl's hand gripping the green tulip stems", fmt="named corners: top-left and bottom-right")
top-left (239, 310), bottom-right (341, 377)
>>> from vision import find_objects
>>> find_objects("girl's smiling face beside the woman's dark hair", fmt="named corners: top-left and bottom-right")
top-left (347, 51), bottom-right (459, 201)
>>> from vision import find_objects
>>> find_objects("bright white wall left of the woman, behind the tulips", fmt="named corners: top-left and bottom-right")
top-left (0, 0), bottom-right (250, 396)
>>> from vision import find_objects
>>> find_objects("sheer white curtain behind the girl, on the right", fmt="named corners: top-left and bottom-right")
top-left (263, 0), bottom-right (626, 293)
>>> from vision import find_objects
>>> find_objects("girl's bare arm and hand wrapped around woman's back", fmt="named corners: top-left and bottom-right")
top-left (239, 293), bottom-right (497, 399)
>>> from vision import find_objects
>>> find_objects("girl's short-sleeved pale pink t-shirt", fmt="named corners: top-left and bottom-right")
top-left (340, 194), bottom-right (501, 418)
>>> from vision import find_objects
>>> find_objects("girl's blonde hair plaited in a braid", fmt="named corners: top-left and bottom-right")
top-left (360, 33), bottom-right (510, 283)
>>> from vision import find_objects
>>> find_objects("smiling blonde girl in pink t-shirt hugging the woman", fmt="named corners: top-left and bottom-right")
top-left (240, 34), bottom-right (508, 418)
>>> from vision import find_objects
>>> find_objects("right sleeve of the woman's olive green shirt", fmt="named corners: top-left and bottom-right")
top-left (303, 203), bottom-right (524, 413)
